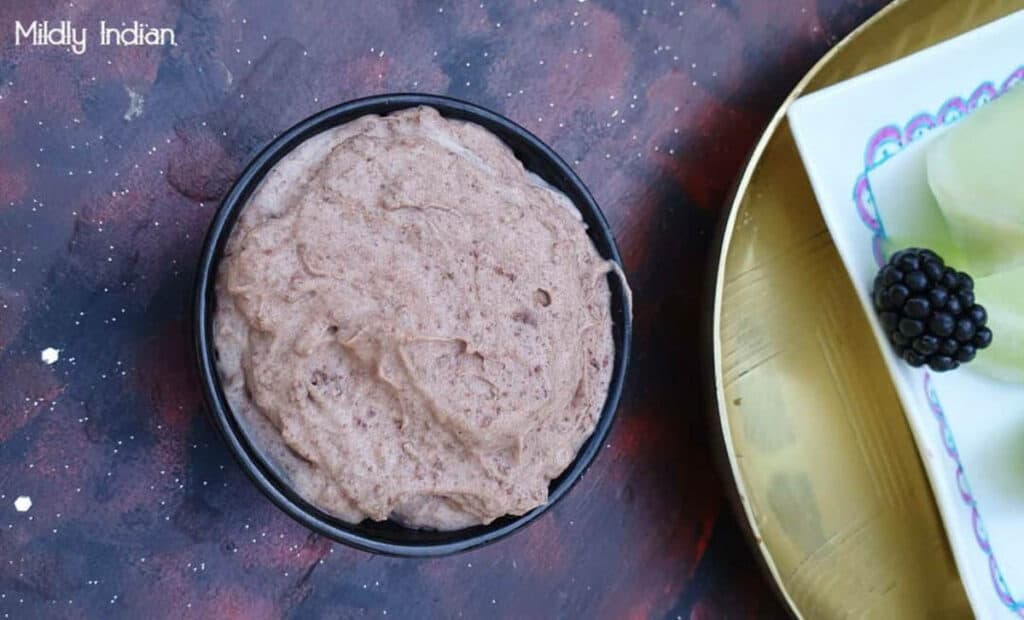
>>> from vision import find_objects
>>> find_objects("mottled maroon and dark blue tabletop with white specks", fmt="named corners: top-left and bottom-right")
top-left (0, 0), bottom-right (884, 618)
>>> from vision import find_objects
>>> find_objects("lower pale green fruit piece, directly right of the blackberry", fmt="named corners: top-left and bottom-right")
top-left (973, 267), bottom-right (1024, 383)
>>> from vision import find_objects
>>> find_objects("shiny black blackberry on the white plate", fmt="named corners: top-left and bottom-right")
top-left (871, 248), bottom-right (992, 372)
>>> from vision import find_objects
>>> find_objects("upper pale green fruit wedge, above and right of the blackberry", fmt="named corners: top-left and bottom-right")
top-left (928, 87), bottom-right (1024, 274)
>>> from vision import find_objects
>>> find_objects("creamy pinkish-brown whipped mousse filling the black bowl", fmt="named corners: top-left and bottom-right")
top-left (214, 108), bottom-right (613, 530)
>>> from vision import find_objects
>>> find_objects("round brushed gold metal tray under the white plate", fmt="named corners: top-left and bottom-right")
top-left (713, 0), bottom-right (1024, 619)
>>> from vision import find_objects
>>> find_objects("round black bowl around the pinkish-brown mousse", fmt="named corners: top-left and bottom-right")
top-left (194, 94), bottom-right (632, 557)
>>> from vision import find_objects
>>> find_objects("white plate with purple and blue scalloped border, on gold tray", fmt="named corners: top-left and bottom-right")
top-left (788, 11), bottom-right (1024, 618)
